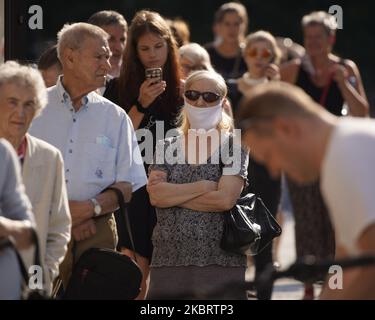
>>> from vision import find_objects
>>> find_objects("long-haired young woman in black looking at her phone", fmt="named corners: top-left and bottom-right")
top-left (104, 10), bottom-right (183, 299)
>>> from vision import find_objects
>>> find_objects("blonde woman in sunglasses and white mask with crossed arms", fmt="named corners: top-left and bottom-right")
top-left (147, 71), bottom-right (248, 299)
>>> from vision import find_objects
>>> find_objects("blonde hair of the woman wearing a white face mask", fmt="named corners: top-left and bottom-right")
top-left (178, 70), bottom-right (233, 135)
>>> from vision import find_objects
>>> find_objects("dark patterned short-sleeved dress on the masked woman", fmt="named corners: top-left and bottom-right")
top-left (148, 137), bottom-right (248, 299)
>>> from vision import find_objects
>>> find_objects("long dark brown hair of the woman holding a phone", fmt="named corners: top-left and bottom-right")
top-left (119, 10), bottom-right (182, 117)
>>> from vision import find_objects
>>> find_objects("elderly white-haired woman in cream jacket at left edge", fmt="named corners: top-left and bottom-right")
top-left (0, 61), bottom-right (71, 292)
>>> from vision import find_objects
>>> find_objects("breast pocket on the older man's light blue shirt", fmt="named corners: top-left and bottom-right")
top-left (82, 143), bottom-right (116, 188)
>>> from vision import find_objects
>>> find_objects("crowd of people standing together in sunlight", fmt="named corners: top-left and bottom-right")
top-left (0, 2), bottom-right (375, 300)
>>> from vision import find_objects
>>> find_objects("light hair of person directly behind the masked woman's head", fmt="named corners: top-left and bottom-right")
top-left (179, 42), bottom-right (214, 71)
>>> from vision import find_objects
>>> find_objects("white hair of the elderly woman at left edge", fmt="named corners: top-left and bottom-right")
top-left (0, 61), bottom-right (47, 115)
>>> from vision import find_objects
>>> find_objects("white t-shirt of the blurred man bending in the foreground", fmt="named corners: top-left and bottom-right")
top-left (320, 117), bottom-right (375, 254)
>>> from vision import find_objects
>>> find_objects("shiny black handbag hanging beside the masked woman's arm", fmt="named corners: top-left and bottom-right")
top-left (220, 137), bottom-right (282, 255)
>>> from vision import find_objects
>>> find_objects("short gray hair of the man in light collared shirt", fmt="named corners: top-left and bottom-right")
top-left (57, 22), bottom-right (109, 62)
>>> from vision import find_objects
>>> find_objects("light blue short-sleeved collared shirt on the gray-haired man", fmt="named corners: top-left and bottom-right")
top-left (29, 77), bottom-right (147, 201)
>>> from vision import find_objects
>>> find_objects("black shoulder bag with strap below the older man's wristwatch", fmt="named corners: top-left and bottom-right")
top-left (63, 187), bottom-right (142, 300)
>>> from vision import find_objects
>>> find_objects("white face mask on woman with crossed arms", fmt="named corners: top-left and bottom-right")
top-left (184, 100), bottom-right (223, 130)
